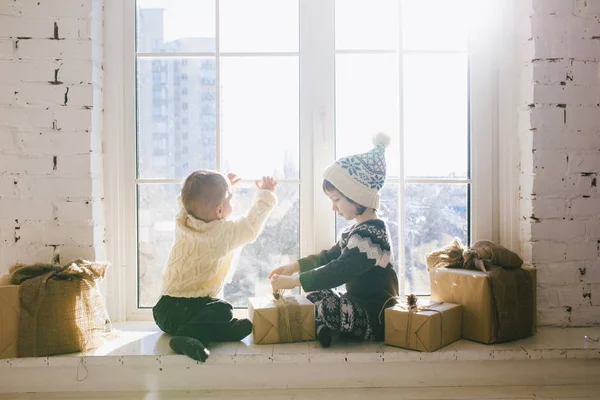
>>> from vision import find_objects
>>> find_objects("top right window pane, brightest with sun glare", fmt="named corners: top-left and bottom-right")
top-left (402, 0), bottom-right (472, 50)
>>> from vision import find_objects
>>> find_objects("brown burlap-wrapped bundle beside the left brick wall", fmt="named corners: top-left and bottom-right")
top-left (10, 260), bottom-right (109, 357)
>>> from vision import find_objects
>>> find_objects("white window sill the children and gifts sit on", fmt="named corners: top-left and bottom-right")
top-left (0, 322), bottom-right (600, 392)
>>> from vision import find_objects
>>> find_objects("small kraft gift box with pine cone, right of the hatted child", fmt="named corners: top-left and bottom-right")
top-left (385, 303), bottom-right (462, 351)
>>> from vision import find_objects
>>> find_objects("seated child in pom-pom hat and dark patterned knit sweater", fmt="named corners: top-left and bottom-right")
top-left (269, 134), bottom-right (398, 347)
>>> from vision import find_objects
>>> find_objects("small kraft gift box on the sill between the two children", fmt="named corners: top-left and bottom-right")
top-left (248, 295), bottom-right (315, 344)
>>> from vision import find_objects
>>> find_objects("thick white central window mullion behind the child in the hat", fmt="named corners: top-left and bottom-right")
top-left (299, 0), bottom-right (335, 256)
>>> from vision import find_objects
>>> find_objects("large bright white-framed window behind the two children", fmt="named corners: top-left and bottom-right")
top-left (115, 0), bottom-right (494, 318)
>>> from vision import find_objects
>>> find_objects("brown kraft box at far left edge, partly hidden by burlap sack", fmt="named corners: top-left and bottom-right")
top-left (0, 275), bottom-right (21, 359)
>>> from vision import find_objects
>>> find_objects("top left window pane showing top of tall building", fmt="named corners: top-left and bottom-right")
top-left (137, 0), bottom-right (216, 53)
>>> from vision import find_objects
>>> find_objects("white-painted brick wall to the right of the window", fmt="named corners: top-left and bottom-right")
top-left (518, 0), bottom-right (600, 326)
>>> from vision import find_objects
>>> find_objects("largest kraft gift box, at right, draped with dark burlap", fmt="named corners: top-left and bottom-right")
top-left (429, 265), bottom-right (536, 344)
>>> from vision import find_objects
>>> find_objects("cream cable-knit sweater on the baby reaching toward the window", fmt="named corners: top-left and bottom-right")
top-left (161, 190), bottom-right (277, 297)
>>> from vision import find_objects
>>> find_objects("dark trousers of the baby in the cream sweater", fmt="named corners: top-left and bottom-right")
top-left (152, 296), bottom-right (239, 346)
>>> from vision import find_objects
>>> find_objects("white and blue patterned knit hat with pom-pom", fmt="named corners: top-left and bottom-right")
top-left (323, 132), bottom-right (390, 209)
